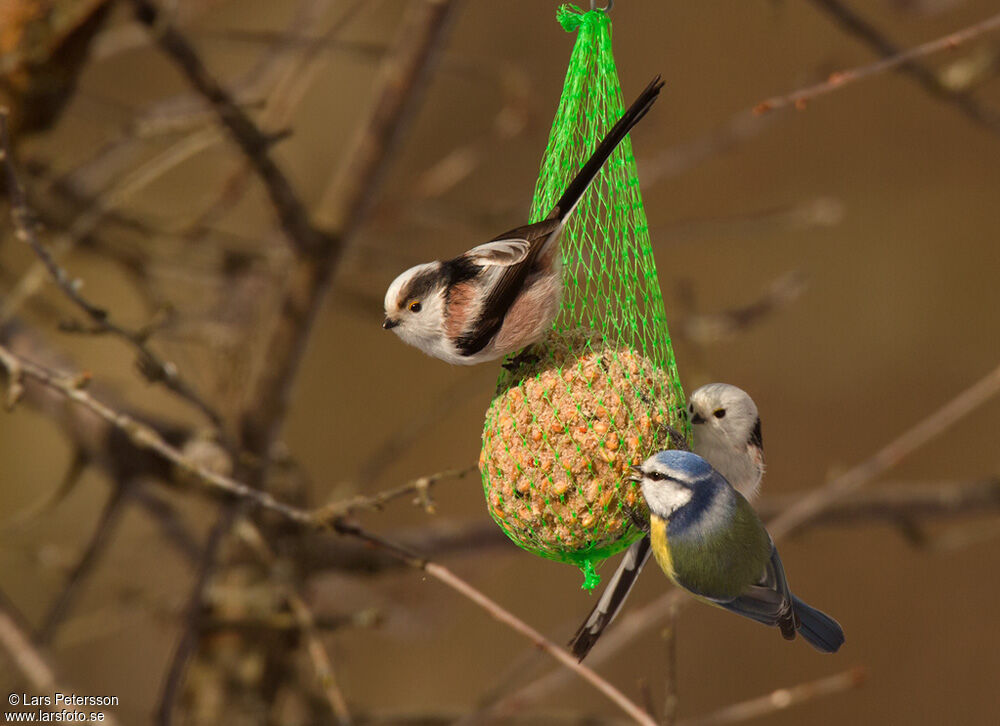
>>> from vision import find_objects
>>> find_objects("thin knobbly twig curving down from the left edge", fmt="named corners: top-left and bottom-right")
top-left (0, 108), bottom-right (222, 426)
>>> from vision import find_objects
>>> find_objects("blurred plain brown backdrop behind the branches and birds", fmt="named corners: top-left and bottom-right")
top-left (0, 0), bottom-right (1000, 724)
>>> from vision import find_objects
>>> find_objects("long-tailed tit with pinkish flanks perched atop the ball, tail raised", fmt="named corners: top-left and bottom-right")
top-left (382, 76), bottom-right (663, 365)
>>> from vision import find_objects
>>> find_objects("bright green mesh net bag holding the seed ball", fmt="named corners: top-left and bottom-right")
top-left (479, 5), bottom-right (690, 589)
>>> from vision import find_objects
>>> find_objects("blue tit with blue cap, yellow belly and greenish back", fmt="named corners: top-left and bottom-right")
top-left (634, 451), bottom-right (844, 653)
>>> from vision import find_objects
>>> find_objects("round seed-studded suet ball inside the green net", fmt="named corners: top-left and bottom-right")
top-left (479, 330), bottom-right (686, 564)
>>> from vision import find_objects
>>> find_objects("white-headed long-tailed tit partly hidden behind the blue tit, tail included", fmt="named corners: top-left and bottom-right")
top-left (569, 383), bottom-right (764, 660)
